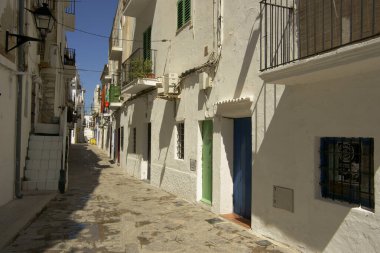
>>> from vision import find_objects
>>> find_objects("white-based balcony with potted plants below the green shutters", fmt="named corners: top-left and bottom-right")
top-left (122, 48), bottom-right (157, 94)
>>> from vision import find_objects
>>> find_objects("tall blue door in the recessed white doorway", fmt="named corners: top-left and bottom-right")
top-left (233, 118), bottom-right (252, 219)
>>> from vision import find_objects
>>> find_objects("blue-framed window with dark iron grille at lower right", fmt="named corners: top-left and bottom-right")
top-left (320, 137), bottom-right (374, 209)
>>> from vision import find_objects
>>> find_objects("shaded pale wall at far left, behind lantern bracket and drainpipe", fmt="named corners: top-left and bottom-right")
top-left (0, 0), bottom-right (37, 206)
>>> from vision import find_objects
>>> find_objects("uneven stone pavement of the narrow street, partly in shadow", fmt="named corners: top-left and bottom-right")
top-left (2, 145), bottom-right (291, 253)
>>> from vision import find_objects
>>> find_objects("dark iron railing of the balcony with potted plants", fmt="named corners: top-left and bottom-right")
top-left (122, 48), bottom-right (157, 86)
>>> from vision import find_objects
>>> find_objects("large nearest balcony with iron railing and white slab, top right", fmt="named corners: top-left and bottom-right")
top-left (260, 0), bottom-right (380, 85)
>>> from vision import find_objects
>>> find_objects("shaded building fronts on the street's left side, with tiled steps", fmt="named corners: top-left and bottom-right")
top-left (0, 0), bottom-right (76, 206)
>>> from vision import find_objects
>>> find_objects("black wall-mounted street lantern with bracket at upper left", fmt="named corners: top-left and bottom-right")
top-left (5, 3), bottom-right (55, 53)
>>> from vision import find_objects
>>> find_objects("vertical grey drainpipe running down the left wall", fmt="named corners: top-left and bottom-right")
top-left (15, 0), bottom-right (25, 199)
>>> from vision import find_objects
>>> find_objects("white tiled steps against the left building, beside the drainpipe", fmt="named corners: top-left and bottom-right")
top-left (23, 135), bottom-right (62, 191)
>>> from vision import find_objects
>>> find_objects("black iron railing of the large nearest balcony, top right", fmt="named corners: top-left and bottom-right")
top-left (260, 0), bottom-right (380, 71)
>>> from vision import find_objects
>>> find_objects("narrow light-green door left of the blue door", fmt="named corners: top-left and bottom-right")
top-left (202, 120), bottom-right (213, 205)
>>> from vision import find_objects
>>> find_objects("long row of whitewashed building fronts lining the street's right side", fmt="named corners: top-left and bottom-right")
top-left (98, 0), bottom-right (380, 252)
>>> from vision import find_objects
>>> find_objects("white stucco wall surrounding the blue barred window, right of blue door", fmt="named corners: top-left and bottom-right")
top-left (252, 73), bottom-right (380, 252)
